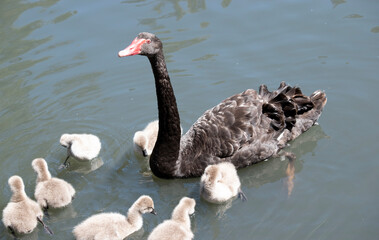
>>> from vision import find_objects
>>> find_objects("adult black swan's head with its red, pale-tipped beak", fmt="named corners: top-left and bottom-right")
top-left (118, 32), bottom-right (162, 57)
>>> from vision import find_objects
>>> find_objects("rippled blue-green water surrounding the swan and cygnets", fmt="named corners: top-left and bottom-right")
top-left (0, 0), bottom-right (379, 240)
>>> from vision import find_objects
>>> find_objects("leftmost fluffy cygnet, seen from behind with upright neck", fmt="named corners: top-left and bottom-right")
top-left (3, 175), bottom-right (53, 236)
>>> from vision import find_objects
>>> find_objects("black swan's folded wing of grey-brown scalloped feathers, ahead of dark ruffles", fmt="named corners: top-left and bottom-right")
top-left (181, 89), bottom-right (264, 159)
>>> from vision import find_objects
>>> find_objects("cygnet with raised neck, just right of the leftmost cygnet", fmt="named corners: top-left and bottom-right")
top-left (32, 158), bottom-right (75, 210)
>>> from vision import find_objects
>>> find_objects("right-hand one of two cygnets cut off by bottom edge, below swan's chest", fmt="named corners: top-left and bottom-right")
top-left (147, 197), bottom-right (196, 240)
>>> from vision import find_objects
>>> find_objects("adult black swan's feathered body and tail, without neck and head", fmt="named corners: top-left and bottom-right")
top-left (175, 82), bottom-right (326, 177)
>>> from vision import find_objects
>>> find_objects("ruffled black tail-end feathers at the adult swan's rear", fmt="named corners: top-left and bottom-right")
top-left (259, 82), bottom-right (326, 136)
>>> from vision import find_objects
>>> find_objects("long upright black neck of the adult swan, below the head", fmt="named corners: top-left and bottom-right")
top-left (149, 50), bottom-right (181, 178)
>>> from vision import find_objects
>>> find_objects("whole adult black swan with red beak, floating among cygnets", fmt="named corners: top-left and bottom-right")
top-left (118, 32), bottom-right (327, 178)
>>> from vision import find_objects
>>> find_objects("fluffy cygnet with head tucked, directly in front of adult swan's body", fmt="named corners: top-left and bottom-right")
top-left (200, 162), bottom-right (247, 203)
